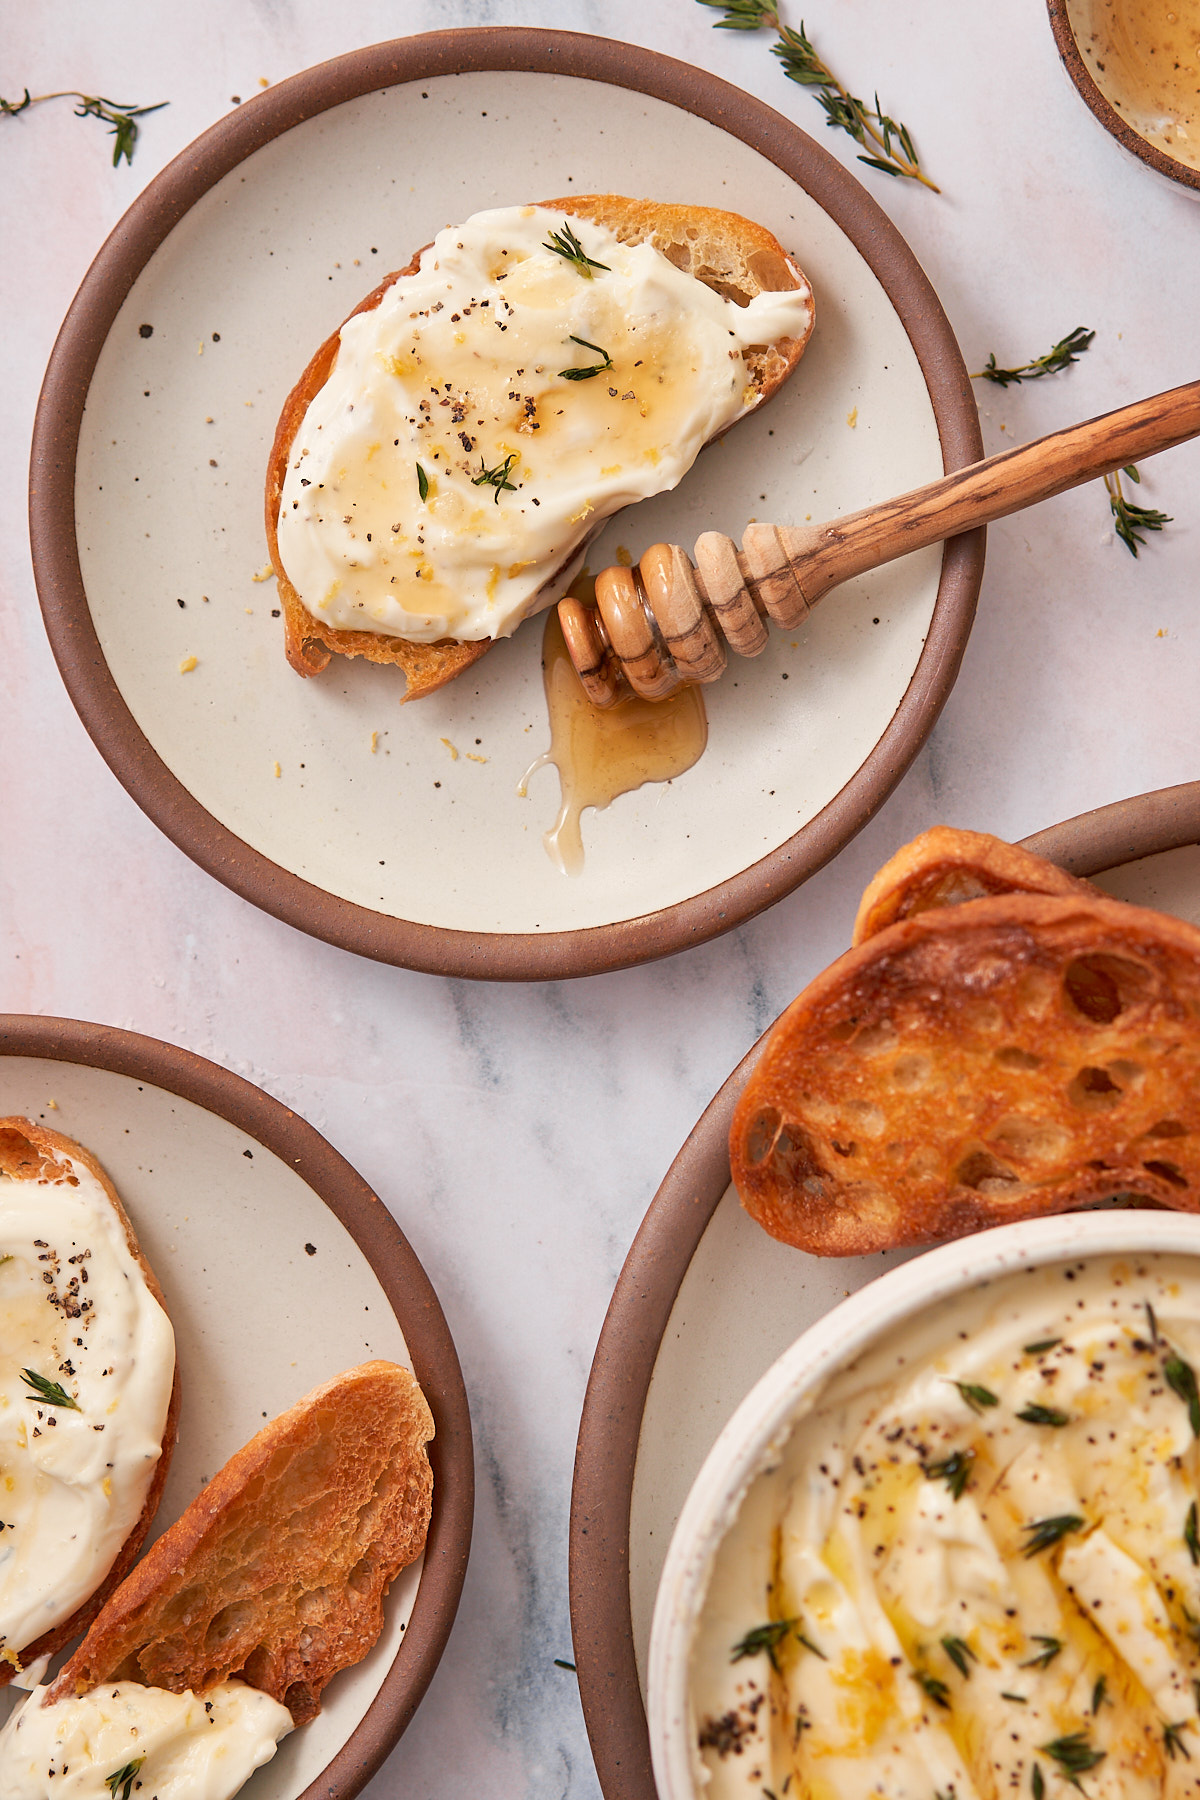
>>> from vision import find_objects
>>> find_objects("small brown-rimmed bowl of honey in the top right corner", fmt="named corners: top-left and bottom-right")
top-left (1047, 0), bottom-right (1200, 198)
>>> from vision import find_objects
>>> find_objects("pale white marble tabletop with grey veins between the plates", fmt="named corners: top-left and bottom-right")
top-left (0, 0), bottom-right (1200, 1800)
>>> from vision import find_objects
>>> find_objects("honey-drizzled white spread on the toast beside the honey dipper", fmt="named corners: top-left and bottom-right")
top-left (279, 207), bottom-right (811, 643)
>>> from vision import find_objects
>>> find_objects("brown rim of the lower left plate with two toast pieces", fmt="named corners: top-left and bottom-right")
top-left (0, 1013), bottom-right (475, 1800)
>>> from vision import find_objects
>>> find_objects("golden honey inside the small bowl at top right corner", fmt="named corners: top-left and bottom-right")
top-left (1069, 0), bottom-right (1200, 169)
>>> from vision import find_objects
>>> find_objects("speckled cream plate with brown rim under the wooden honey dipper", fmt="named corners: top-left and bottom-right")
top-left (31, 29), bottom-right (982, 979)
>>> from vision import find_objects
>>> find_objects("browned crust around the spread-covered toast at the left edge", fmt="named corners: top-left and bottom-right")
top-left (0, 1118), bottom-right (180, 1687)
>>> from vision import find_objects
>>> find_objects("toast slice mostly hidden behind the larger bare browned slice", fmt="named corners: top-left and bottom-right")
top-left (851, 824), bottom-right (1099, 943)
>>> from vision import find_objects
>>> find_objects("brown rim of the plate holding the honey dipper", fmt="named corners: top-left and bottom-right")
top-left (29, 27), bottom-right (984, 981)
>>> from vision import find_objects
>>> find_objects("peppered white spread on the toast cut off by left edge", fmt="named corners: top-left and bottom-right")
top-left (0, 1159), bottom-right (175, 1656)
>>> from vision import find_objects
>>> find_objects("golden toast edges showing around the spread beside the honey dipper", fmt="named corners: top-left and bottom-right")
top-left (266, 194), bottom-right (811, 700)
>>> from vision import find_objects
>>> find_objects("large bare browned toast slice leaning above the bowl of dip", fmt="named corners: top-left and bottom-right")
top-left (730, 893), bottom-right (1200, 1256)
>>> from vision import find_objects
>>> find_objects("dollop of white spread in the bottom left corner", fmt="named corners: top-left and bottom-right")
top-left (0, 1681), bottom-right (291, 1800)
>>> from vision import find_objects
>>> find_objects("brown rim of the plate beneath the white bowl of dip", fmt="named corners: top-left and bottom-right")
top-left (569, 781), bottom-right (1200, 1800)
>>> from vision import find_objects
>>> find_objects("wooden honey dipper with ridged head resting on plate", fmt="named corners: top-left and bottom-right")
top-left (558, 382), bottom-right (1200, 707)
